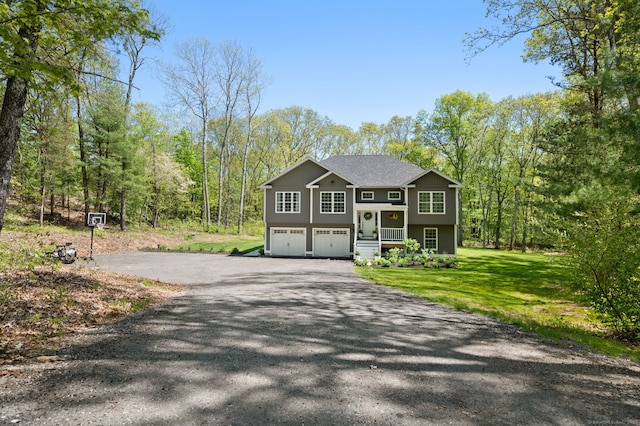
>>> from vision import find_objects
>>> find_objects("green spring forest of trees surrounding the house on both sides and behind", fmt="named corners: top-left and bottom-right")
top-left (0, 0), bottom-right (640, 334)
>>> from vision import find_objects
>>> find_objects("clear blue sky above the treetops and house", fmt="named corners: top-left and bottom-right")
top-left (134, 0), bottom-right (559, 130)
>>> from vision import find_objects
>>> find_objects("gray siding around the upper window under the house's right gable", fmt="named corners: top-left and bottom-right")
top-left (408, 173), bottom-right (457, 225)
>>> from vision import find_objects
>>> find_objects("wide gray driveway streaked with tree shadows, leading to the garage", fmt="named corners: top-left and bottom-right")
top-left (0, 253), bottom-right (640, 425)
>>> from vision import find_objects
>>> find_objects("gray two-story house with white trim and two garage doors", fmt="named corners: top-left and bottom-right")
top-left (261, 155), bottom-right (462, 258)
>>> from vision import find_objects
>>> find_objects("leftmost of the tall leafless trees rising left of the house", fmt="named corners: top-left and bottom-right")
top-left (162, 38), bottom-right (218, 231)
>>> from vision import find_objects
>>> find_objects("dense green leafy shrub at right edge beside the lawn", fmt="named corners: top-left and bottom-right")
top-left (567, 187), bottom-right (640, 341)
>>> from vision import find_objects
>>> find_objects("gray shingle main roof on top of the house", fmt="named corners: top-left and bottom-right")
top-left (320, 155), bottom-right (425, 187)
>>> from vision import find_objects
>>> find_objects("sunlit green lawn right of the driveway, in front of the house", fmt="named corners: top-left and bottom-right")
top-left (356, 248), bottom-right (640, 360)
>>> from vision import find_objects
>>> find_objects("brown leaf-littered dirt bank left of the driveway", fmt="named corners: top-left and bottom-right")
top-left (0, 226), bottom-right (240, 362)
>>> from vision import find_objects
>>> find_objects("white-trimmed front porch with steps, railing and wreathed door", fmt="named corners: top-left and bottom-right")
top-left (354, 204), bottom-right (408, 259)
